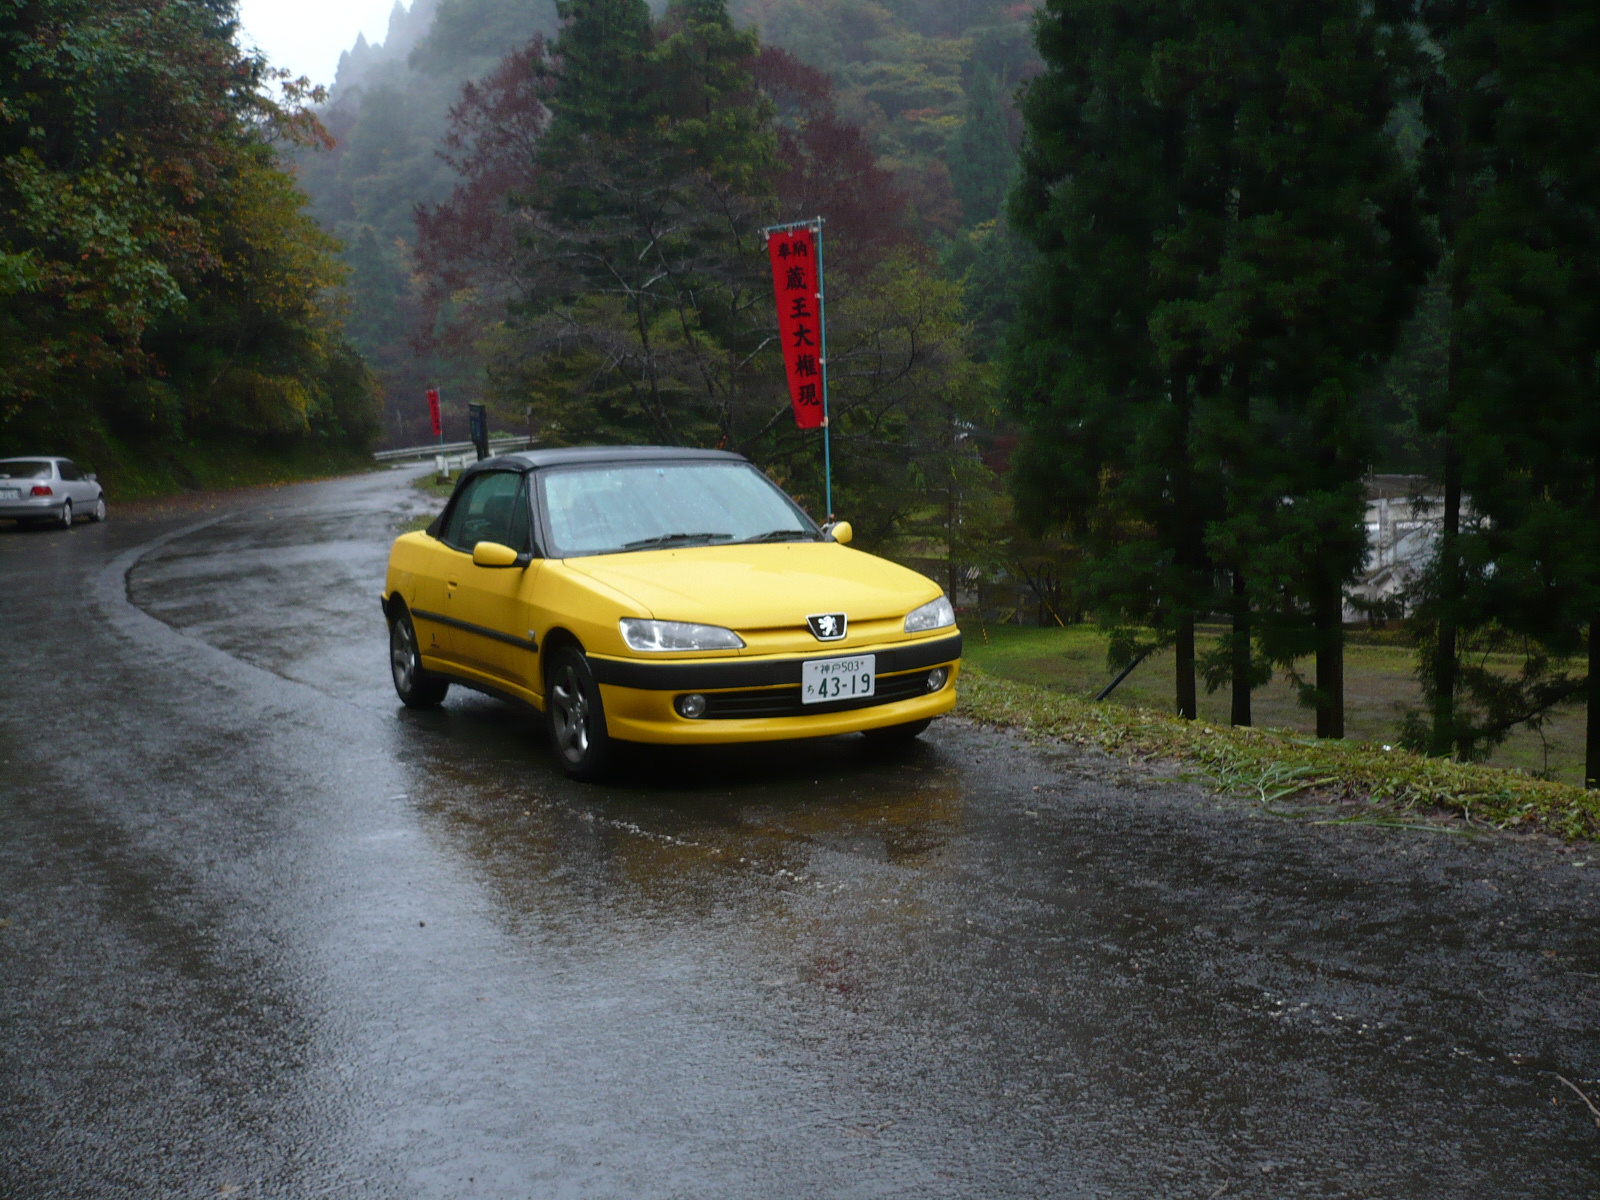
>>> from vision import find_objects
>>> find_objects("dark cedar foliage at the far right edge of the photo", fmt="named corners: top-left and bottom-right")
top-left (1411, 0), bottom-right (1600, 782)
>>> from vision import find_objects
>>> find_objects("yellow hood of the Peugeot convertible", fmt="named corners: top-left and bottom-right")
top-left (566, 542), bottom-right (941, 629)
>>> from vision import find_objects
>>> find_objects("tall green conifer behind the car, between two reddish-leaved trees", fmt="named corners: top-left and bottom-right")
top-left (518, 0), bottom-right (773, 443)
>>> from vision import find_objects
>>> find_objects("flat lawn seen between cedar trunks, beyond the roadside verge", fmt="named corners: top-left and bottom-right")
top-left (963, 621), bottom-right (1584, 786)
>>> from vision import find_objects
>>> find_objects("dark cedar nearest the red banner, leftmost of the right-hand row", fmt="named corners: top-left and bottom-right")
top-left (1008, 0), bottom-right (1216, 718)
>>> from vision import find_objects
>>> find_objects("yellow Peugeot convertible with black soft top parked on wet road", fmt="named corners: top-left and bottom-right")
top-left (382, 446), bottom-right (962, 778)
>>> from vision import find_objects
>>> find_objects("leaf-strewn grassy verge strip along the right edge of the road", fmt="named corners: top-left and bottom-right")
top-left (958, 668), bottom-right (1600, 842)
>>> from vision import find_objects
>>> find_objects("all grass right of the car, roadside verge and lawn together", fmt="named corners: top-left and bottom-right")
top-left (962, 622), bottom-right (1600, 838)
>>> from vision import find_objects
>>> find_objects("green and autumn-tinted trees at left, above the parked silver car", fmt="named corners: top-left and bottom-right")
top-left (0, 0), bottom-right (374, 464)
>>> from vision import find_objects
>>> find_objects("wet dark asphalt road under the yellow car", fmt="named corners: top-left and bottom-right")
top-left (0, 472), bottom-right (1600, 1200)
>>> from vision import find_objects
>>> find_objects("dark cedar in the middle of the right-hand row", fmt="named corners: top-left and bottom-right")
top-left (1187, 0), bottom-right (1434, 738)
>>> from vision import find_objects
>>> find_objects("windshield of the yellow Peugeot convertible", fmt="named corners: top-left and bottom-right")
top-left (539, 462), bottom-right (818, 558)
